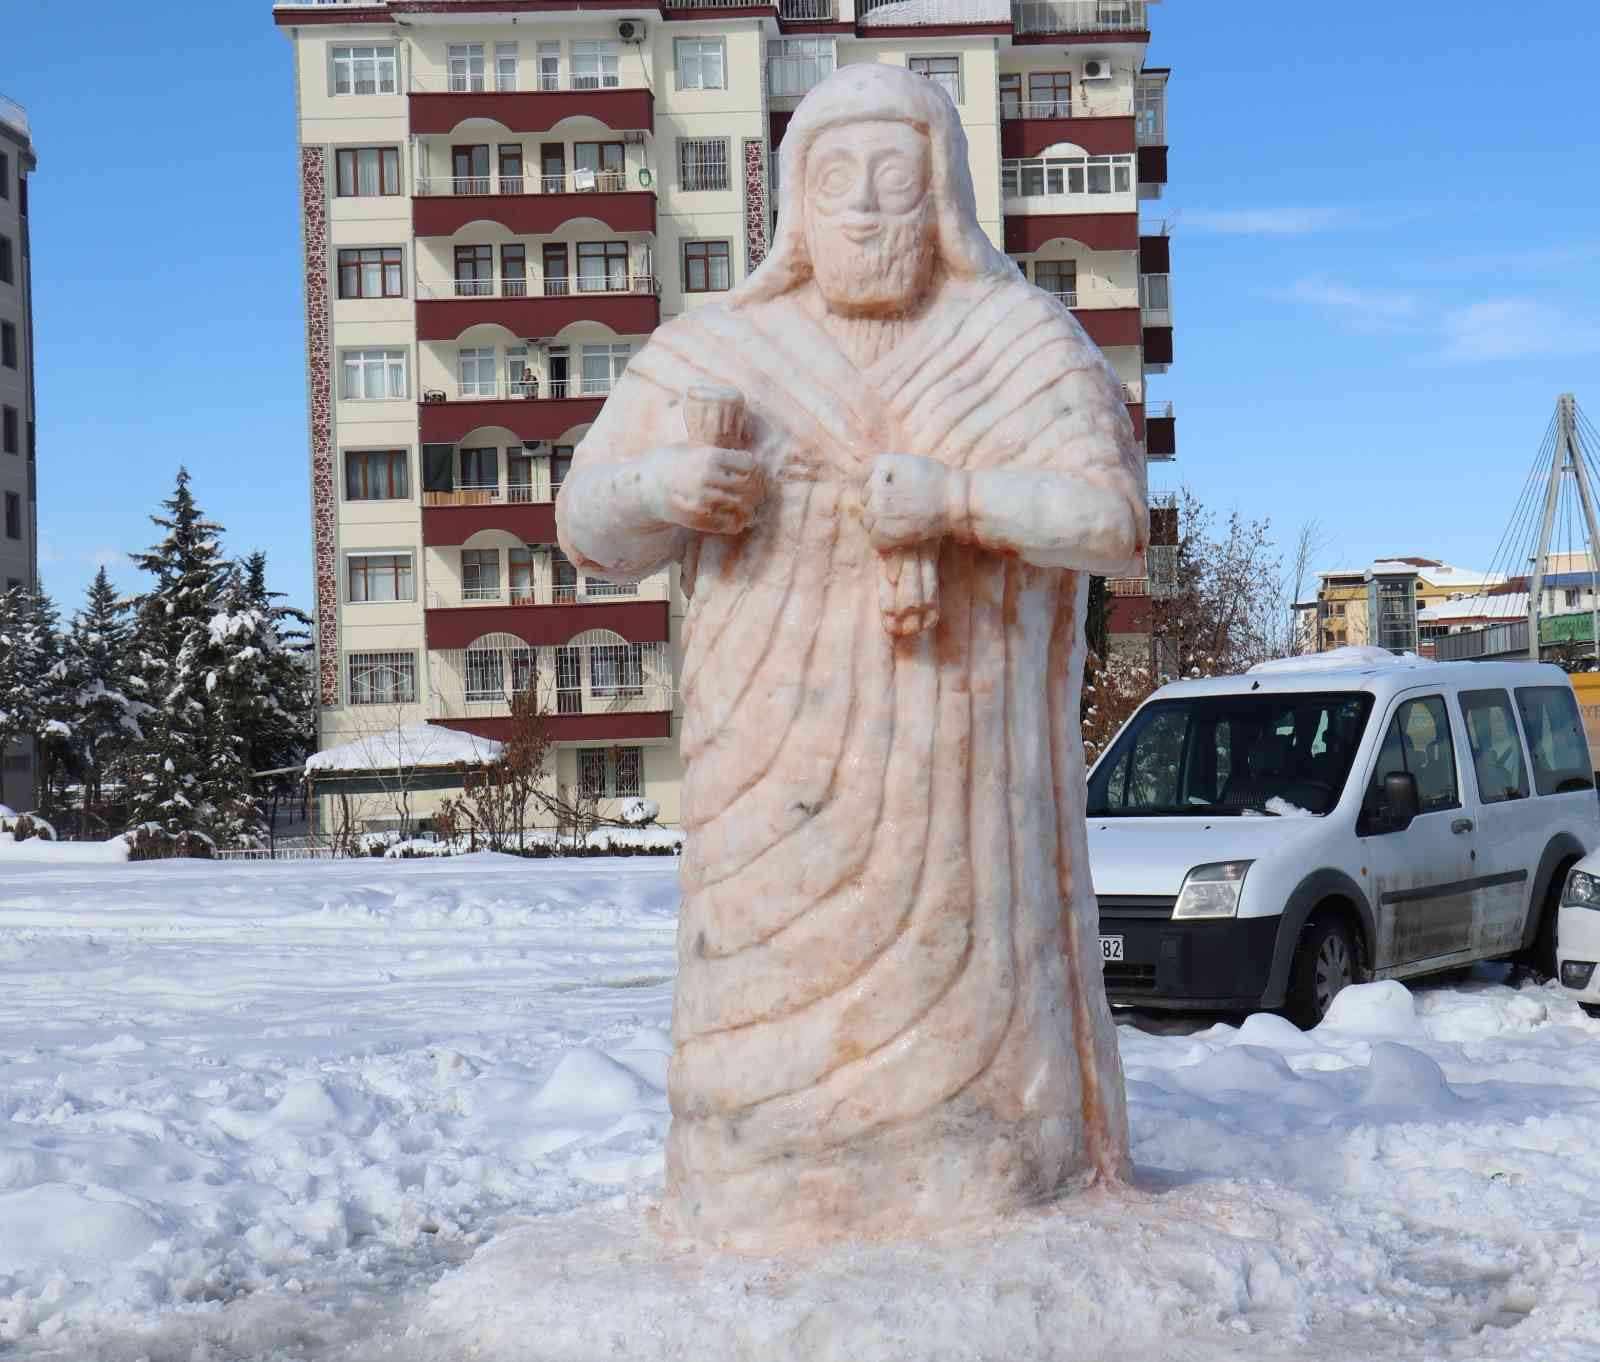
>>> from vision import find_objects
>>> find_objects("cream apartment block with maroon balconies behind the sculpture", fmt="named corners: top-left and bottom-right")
top-left (274, 0), bottom-right (1174, 823)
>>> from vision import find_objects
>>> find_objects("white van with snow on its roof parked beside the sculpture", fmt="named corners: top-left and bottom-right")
top-left (1086, 648), bottom-right (1600, 1024)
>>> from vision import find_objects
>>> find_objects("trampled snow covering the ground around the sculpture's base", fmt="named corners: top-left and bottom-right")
top-left (0, 848), bottom-right (1600, 1362)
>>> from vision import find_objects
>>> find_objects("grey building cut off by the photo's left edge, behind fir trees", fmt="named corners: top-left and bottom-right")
top-left (0, 94), bottom-right (38, 808)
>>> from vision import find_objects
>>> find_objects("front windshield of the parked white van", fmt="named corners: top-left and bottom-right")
top-left (1088, 691), bottom-right (1373, 818)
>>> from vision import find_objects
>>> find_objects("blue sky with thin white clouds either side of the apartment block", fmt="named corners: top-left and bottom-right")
top-left (0, 0), bottom-right (1600, 605)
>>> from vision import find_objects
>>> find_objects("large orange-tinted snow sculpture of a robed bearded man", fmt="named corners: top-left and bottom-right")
top-left (557, 64), bottom-right (1146, 1252)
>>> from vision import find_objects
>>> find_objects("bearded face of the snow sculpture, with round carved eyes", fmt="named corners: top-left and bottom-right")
top-left (805, 120), bottom-right (938, 317)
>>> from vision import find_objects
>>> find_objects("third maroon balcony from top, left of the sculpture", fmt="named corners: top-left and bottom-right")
top-left (416, 274), bottom-right (661, 340)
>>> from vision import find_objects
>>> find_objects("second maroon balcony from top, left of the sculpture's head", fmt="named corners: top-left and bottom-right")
top-left (411, 171), bottom-right (656, 237)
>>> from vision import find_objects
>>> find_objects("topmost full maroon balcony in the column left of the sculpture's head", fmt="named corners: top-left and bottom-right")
top-left (408, 74), bottom-right (656, 133)
